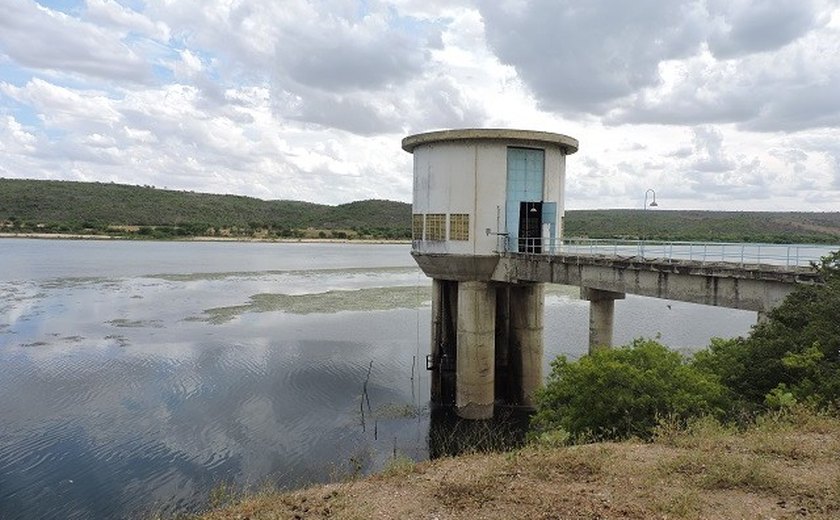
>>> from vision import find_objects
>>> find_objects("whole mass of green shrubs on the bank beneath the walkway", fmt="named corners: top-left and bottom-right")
top-left (532, 252), bottom-right (840, 441)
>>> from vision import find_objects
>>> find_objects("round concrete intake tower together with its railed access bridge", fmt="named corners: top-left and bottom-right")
top-left (402, 128), bottom-right (827, 419)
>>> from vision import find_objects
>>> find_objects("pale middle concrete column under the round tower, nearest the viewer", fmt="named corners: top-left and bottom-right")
top-left (455, 282), bottom-right (496, 419)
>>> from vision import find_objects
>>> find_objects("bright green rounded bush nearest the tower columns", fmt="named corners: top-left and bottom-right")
top-left (532, 339), bottom-right (727, 440)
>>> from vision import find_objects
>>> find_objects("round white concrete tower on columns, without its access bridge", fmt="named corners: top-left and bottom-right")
top-left (402, 129), bottom-right (578, 419)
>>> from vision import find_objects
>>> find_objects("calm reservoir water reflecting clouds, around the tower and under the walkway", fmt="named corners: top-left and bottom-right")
top-left (0, 239), bottom-right (755, 520)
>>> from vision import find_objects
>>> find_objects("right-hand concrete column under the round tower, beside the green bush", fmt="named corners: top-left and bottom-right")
top-left (510, 283), bottom-right (545, 407)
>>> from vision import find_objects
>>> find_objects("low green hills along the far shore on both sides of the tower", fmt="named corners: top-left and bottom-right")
top-left (0, 179), bottom-right (840, 244)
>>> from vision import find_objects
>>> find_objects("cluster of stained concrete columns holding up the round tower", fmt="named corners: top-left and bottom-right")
top-left (427, 279), bottom-right (544, 419)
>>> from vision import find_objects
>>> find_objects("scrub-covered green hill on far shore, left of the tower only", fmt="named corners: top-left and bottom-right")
top-left (0, 179), bottom-right (411, 239)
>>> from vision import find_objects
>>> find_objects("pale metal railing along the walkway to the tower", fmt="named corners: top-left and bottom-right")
top-left (508, 238), bottom-right (840, 267)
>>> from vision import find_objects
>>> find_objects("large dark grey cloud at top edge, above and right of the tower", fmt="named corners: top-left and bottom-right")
top-left (479, 0), bottom-right (705, 113)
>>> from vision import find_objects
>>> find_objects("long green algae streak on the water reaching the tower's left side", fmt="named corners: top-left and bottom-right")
top-left (199, 286), bottom-right (431, 325)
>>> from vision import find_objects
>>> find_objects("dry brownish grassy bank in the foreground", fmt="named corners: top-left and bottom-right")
top-left (195, 412), bottom-right (840, 520)
